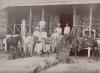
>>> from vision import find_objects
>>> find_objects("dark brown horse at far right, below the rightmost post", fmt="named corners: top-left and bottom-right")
top-left (80, 37), bottom-right (99, 58)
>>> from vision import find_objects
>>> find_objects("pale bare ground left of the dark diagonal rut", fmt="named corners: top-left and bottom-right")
top-left (0, 57), bottom-right (56, 73)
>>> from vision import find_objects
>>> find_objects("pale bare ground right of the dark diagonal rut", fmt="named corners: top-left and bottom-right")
top-left (41, 57), bottom-right (100, 73)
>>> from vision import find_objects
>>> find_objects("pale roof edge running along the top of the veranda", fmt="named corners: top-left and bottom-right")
top-left (0, 0), bottom-right (100, 9)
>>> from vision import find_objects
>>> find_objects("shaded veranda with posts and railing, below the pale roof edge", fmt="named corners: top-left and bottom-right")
top-left (1, 4), bottom-right (100, 56)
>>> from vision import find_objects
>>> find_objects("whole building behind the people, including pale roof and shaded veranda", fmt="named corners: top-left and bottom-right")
top-left (0, 0), bottom-right (100, 38)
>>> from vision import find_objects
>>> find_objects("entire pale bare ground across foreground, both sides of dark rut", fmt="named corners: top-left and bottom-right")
top-left (0, 53), bottom-right (100, 73)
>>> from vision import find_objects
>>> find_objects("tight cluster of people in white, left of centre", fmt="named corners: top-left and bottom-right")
top-left (33, 21), bottom-right (47, 54)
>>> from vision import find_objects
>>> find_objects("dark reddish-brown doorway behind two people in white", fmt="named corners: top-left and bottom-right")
top-left (60, 13), bottom-right (73, 34)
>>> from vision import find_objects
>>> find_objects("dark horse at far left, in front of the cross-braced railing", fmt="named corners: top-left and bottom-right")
top-left (6, 36), bottom-right (22, 59)
